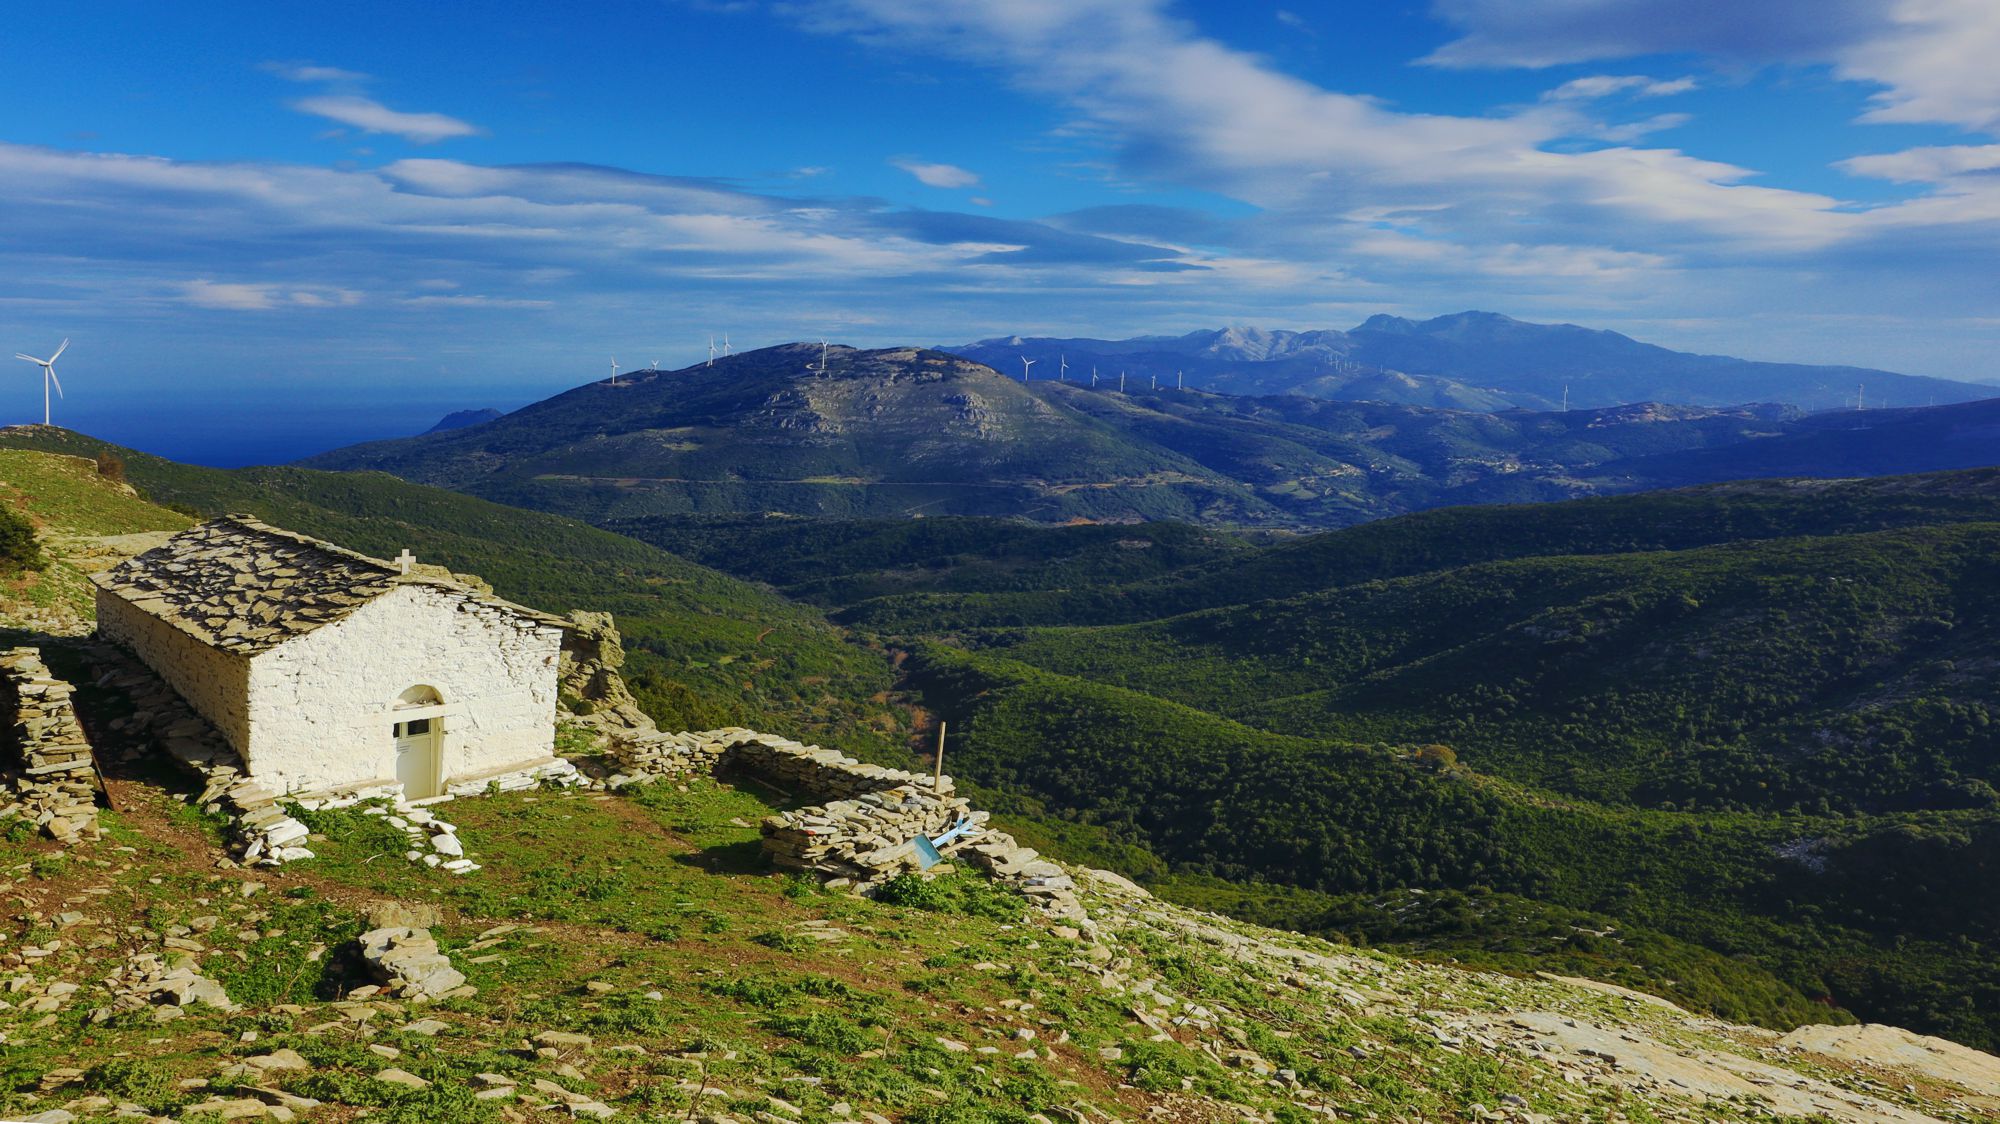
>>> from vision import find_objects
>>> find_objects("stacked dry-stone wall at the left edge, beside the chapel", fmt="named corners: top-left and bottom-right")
top-left (0, 648), bottom-right (100, 842)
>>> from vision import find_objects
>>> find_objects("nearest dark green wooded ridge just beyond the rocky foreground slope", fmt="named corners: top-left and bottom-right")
top-left (916, 648), bottom-right (2000, 1046)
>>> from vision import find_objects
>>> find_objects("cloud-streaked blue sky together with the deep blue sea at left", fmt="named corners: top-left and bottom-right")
top-left (0, 0), bottom-right (2000, 462)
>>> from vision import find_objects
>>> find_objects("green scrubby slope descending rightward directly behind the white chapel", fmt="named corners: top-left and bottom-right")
top-left (0, 428), bottom-right (904, 754)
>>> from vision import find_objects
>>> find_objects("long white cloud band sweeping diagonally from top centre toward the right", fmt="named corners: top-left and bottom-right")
top-left (818, 0), bottom-right (1848, 252)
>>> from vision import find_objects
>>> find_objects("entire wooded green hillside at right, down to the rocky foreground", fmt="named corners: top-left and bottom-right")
top-left (740, 470), bottom-right (2000, 1042)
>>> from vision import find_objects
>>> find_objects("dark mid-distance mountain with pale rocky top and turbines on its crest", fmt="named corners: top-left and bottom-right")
top-left (306, 344), bottom-right (1840, 528)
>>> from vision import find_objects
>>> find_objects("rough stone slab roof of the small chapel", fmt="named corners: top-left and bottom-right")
top-left (90, 516), bottom-right (564, 654)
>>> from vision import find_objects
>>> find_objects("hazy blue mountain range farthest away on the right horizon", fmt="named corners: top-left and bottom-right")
top-left (946, 312), bottom-right (2000, 410)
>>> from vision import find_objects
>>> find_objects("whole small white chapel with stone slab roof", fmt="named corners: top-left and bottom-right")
top-left (92, 516), bottom-right (564, 800)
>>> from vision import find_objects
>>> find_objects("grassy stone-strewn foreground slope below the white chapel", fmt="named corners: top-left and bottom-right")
top-left (15, 764), bottom-right (1962, 1124)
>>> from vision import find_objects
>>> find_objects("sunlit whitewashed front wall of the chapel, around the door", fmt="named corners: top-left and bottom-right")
top-left (248, 584), bottom-right (562, 792)
